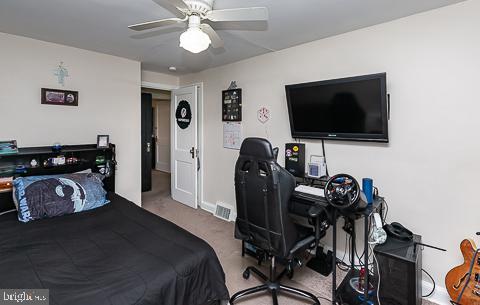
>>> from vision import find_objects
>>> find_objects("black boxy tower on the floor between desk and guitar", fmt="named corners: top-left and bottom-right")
top-left (374, 235), bottom-right (422, 305)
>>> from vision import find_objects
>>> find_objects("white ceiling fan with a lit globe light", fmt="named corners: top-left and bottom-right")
top-left (128, 0), bottom-right (268, 53)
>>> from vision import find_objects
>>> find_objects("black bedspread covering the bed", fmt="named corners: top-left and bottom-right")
top-left (0, 195), bottom-right (228, 305)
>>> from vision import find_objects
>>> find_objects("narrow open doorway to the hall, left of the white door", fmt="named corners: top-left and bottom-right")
top-left (142, 87), bottom-right (171, 201)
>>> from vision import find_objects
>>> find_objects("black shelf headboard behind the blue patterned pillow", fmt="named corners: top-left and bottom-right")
top-left (0, 144), bottom-right (116, 213)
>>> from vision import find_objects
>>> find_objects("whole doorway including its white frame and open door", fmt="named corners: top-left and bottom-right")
top-left (142, 82), bottom-right (204, 211)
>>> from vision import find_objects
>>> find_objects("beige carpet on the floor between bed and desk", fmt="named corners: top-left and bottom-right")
top-left (142, 171), bottom-right (433, 305)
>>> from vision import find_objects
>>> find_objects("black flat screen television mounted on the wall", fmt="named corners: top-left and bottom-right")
top-left (285, 73), bottom-right (389, 142)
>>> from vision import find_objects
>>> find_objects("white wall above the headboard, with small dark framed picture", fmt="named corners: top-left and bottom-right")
top-left (0, 33), bottom-right (141, 204)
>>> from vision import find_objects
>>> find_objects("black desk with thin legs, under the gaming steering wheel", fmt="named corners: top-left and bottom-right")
top-left (289, 191), bottom-right (383, 305)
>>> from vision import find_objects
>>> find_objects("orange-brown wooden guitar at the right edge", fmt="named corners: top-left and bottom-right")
top-left (445, 239), bottom-right (480, 305)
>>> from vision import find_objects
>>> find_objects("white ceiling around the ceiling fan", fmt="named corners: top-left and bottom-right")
top-left (0, 0), bottom-right (462, 74)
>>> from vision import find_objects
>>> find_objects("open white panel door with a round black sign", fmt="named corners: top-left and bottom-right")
top-left (171, 86), bottom-right (198, 208)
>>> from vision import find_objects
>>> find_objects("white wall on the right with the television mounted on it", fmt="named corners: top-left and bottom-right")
top-left (181, 0), bottom-right (480, 300)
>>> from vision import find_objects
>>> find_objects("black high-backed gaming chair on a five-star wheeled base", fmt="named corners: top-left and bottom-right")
top-left (230, 138), bottom-right (320, 305)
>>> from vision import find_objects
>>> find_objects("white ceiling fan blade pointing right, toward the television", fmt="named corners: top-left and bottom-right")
top-left (205, 7), bottom-right (268, 21)
